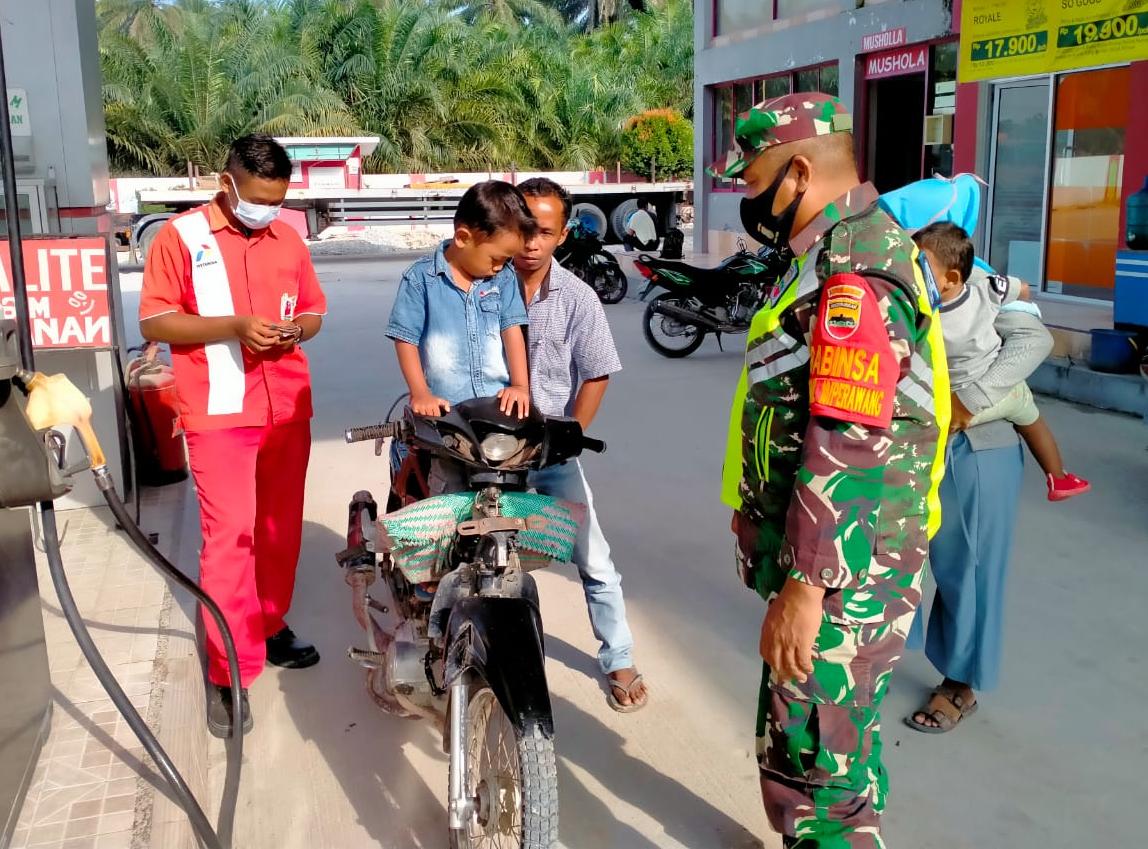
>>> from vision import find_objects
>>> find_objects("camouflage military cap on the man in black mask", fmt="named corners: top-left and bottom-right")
top-left (706, 92), bottom-right (853, 177)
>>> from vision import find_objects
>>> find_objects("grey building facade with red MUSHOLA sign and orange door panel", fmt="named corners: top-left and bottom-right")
top-left (695, 0), bottom-right (1148, 301)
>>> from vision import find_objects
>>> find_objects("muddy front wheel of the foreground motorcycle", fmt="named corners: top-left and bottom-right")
top-left (450, 681), bottom-right (558, 849)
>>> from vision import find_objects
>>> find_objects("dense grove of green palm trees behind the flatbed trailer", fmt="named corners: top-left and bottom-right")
top-left (98, 0), bottom-right (692, 173)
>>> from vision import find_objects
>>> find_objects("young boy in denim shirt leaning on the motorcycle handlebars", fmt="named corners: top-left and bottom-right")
top-left (387, 180), bottom-right (537, 494)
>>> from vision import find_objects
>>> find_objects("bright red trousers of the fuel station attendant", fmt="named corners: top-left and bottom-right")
top-left (187, 419), bottom-right (311, 687)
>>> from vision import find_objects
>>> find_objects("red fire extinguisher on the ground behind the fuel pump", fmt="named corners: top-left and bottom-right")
top-left (126, 342), bottom-right (187, 486)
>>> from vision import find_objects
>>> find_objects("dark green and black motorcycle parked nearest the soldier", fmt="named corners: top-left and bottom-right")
top-left (634, 239), bottom-right (789, 358)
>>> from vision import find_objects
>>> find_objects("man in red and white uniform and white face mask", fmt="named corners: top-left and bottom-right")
top-left (140, 135), bottom-right (327, 737)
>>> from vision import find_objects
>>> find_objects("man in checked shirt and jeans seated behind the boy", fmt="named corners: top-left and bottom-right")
top-left (514, 178), bottom-right (649, 712)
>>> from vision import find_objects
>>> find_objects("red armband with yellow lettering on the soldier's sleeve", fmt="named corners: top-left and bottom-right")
top-left (809, 274), bottom-right (900, 428)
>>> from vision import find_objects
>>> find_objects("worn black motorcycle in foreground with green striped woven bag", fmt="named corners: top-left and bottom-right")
top-left (338, 398), bottom-right (605, 849)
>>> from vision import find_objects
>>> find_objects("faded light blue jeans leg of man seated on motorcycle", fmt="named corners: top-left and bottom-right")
top-left (530, 460), bottom-right (634, 675)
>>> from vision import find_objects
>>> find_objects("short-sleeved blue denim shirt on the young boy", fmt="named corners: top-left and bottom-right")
top-left (387, 242), bottom-right (529, 404)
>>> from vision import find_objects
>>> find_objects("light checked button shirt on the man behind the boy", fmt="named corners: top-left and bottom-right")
top-left (527, 262), bottom-right (622, 415)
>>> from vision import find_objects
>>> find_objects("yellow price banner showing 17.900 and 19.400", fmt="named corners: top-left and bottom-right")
top-left (959, 0), bottom-right (1148, 83)
